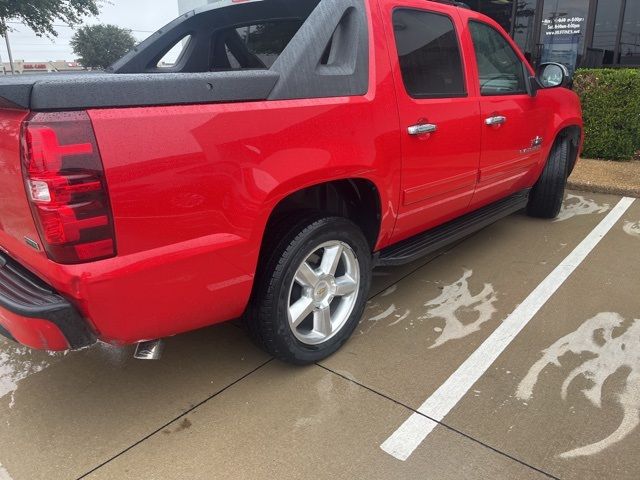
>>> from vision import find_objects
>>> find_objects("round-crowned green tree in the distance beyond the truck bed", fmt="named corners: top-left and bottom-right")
top-left (70, 25), bottom-right (136, 70)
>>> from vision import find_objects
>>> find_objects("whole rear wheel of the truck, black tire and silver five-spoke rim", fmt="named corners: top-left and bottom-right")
top-left (247, 217), bottom-right (371, 364)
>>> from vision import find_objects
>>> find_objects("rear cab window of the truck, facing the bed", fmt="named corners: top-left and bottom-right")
top-left (211, 20), bottom-right (304, 71)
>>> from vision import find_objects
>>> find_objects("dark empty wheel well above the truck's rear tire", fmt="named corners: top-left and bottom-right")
top-left (265, 179), bottom-right (382, 251)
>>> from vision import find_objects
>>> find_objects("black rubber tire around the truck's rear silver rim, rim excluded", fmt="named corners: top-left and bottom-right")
top-left (245, 216), bottom-right (372, 365)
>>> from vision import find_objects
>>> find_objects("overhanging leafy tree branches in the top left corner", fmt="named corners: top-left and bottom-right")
top-left (0, 0), bottom-right (102, 37)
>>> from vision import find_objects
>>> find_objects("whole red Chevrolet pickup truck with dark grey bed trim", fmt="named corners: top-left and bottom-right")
top-left (0, 0), bottom-right (583, 364)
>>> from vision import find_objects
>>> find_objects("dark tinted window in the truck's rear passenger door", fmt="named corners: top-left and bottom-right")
top-left (393, 8), bottom-right (466, 98)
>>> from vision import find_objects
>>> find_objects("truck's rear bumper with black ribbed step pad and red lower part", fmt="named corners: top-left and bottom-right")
top-left (0, 254), bottom-right (96, 351)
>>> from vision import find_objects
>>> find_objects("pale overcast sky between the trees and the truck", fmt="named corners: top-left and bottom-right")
top-left (0, 0), bottom-right (178, 62)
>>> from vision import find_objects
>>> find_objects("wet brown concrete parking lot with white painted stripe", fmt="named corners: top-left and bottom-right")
top-left (0, 192), bottom-right (640, 480)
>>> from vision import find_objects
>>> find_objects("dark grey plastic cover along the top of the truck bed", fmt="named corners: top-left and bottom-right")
top-left (0, 70), bottom-right (280, 111)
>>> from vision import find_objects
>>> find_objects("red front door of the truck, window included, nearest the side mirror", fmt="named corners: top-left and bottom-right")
top-left (468, 17), bottom-right (553, 208)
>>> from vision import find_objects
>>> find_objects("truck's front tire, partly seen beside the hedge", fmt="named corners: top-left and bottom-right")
top-left (527, 138), bottom-right (571, 218)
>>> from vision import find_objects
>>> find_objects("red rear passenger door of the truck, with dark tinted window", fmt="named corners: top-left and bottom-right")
top-left (380, 0), bottom-right (481, 241)
